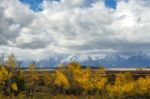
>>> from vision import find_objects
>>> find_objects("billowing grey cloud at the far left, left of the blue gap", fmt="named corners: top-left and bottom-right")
top-left (0, 0), bottom-right (34, 45)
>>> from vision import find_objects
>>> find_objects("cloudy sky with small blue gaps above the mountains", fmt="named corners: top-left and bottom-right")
top-left (0, 0), bottom-right (150, 59)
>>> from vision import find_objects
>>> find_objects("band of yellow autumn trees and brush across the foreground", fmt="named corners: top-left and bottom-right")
top-left (0, 55), bottom-right (150, 99)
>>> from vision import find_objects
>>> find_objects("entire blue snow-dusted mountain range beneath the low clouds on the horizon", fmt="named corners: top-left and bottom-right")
top-left (19, 52), bottom-right (150, 68)
